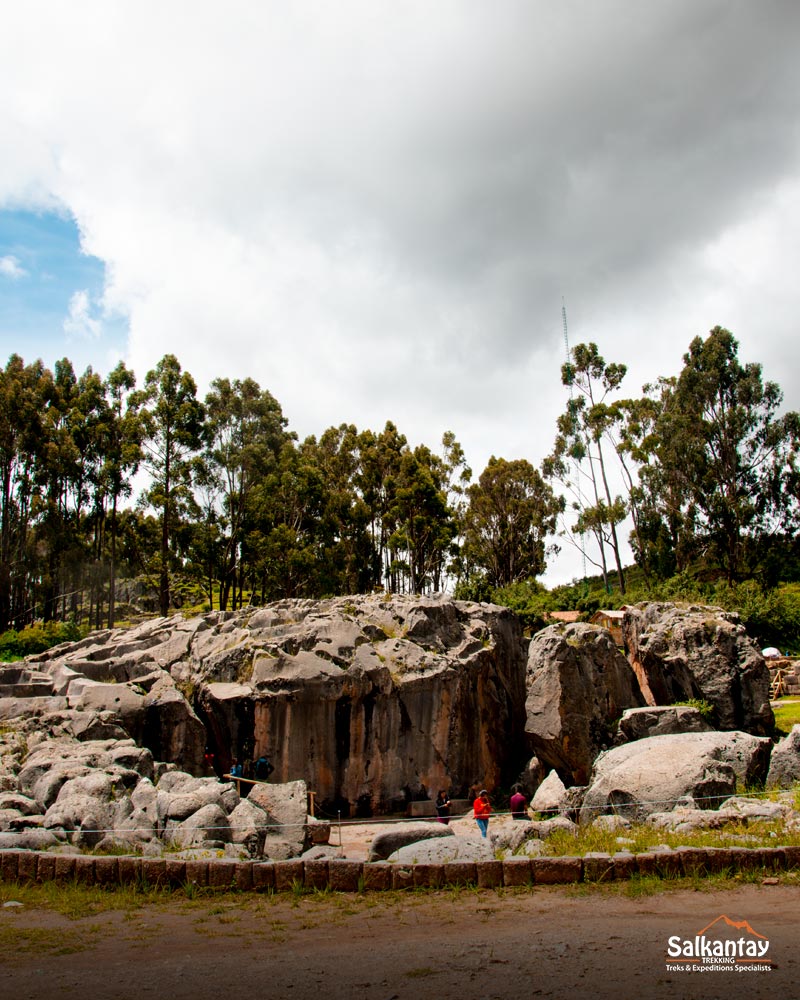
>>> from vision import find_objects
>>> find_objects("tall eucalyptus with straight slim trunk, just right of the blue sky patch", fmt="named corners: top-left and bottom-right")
top-left (134, 354), bottom-right (205, 615)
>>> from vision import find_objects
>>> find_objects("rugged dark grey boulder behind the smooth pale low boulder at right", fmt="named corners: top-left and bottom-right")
top-left (622, 603), bottom-right (774, 736)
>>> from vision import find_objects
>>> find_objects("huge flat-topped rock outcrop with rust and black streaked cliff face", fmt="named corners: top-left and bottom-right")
top-left (0, 595), bottom-right (527, 816)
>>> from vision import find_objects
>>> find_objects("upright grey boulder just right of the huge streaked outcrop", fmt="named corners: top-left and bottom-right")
top-left (525, 622), bottom-right (644, 785)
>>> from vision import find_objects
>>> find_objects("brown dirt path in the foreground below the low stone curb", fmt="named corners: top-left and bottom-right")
top-left (0, 886), bottom-right (800, 1000)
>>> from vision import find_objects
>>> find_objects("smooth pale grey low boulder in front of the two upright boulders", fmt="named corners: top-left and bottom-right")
top-left (580, 732), bottom-right (770, 823)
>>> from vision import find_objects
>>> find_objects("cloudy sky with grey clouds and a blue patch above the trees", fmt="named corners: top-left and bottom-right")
top-left (0, 0), bottom-right (800, 582)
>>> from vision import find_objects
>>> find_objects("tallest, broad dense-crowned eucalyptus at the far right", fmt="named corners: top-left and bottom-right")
top-left (643, 326), bottom-right (800, 583)
